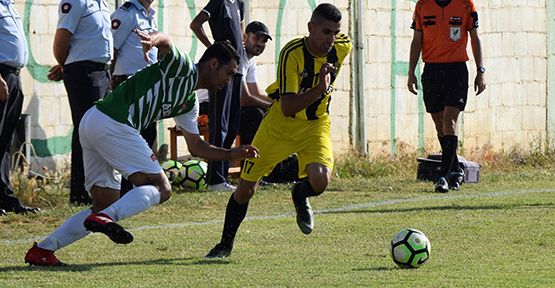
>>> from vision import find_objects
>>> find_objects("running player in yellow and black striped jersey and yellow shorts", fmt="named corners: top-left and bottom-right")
top-left (205, 4), bottom-right (352, 258)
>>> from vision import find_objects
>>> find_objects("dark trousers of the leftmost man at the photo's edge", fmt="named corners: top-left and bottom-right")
top-left (0, 64), bottom-right (23, 210)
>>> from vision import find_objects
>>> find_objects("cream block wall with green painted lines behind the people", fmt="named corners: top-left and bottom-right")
top-left (16, 0), bottom-right (555, 171)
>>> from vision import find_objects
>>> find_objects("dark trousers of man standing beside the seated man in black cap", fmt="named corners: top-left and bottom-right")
top-left (207, 74), bottom-right (243, 185)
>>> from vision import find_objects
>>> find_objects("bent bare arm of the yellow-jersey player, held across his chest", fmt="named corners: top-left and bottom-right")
top-left (280, 63), bottom-right (335, 117)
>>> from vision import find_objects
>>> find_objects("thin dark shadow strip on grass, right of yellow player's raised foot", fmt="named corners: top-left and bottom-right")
top-left (316, 203), bottom-right (555, 214)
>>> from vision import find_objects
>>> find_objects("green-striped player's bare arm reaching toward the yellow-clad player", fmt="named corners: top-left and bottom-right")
top-left (183, 131), bottom-right (258, 160)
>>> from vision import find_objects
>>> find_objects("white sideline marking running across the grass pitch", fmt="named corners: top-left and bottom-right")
top-left (2, 188), bottom-right (555, 245)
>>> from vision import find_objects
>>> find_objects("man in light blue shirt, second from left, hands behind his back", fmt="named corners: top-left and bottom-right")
top-left (48, 0), bottom-right (114, 204)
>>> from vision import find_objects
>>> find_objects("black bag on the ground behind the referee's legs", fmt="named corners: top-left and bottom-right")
top-left (416, 154), bottom-right (480, 183)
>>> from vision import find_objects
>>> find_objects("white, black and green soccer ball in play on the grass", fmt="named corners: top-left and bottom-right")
top-left (391, 228), bottom-right (432, 268)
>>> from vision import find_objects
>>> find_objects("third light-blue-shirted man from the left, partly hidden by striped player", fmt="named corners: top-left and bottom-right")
top-left (110, 0), bottom-right (158, 195)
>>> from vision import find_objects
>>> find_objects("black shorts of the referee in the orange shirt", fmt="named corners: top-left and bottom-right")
top-left (422, 62), bottom-right (468, 113)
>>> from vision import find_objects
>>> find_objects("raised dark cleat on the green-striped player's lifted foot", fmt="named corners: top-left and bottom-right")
top-left (83, 213), bottom-right (133, 244)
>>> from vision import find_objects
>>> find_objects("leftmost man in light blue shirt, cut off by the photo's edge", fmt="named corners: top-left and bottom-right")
top-left (0, 0), bottom-right (39, 216)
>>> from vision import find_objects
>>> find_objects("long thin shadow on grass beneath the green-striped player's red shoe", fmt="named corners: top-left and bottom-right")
top-left (0, 257), bottom-right (231, 273)
